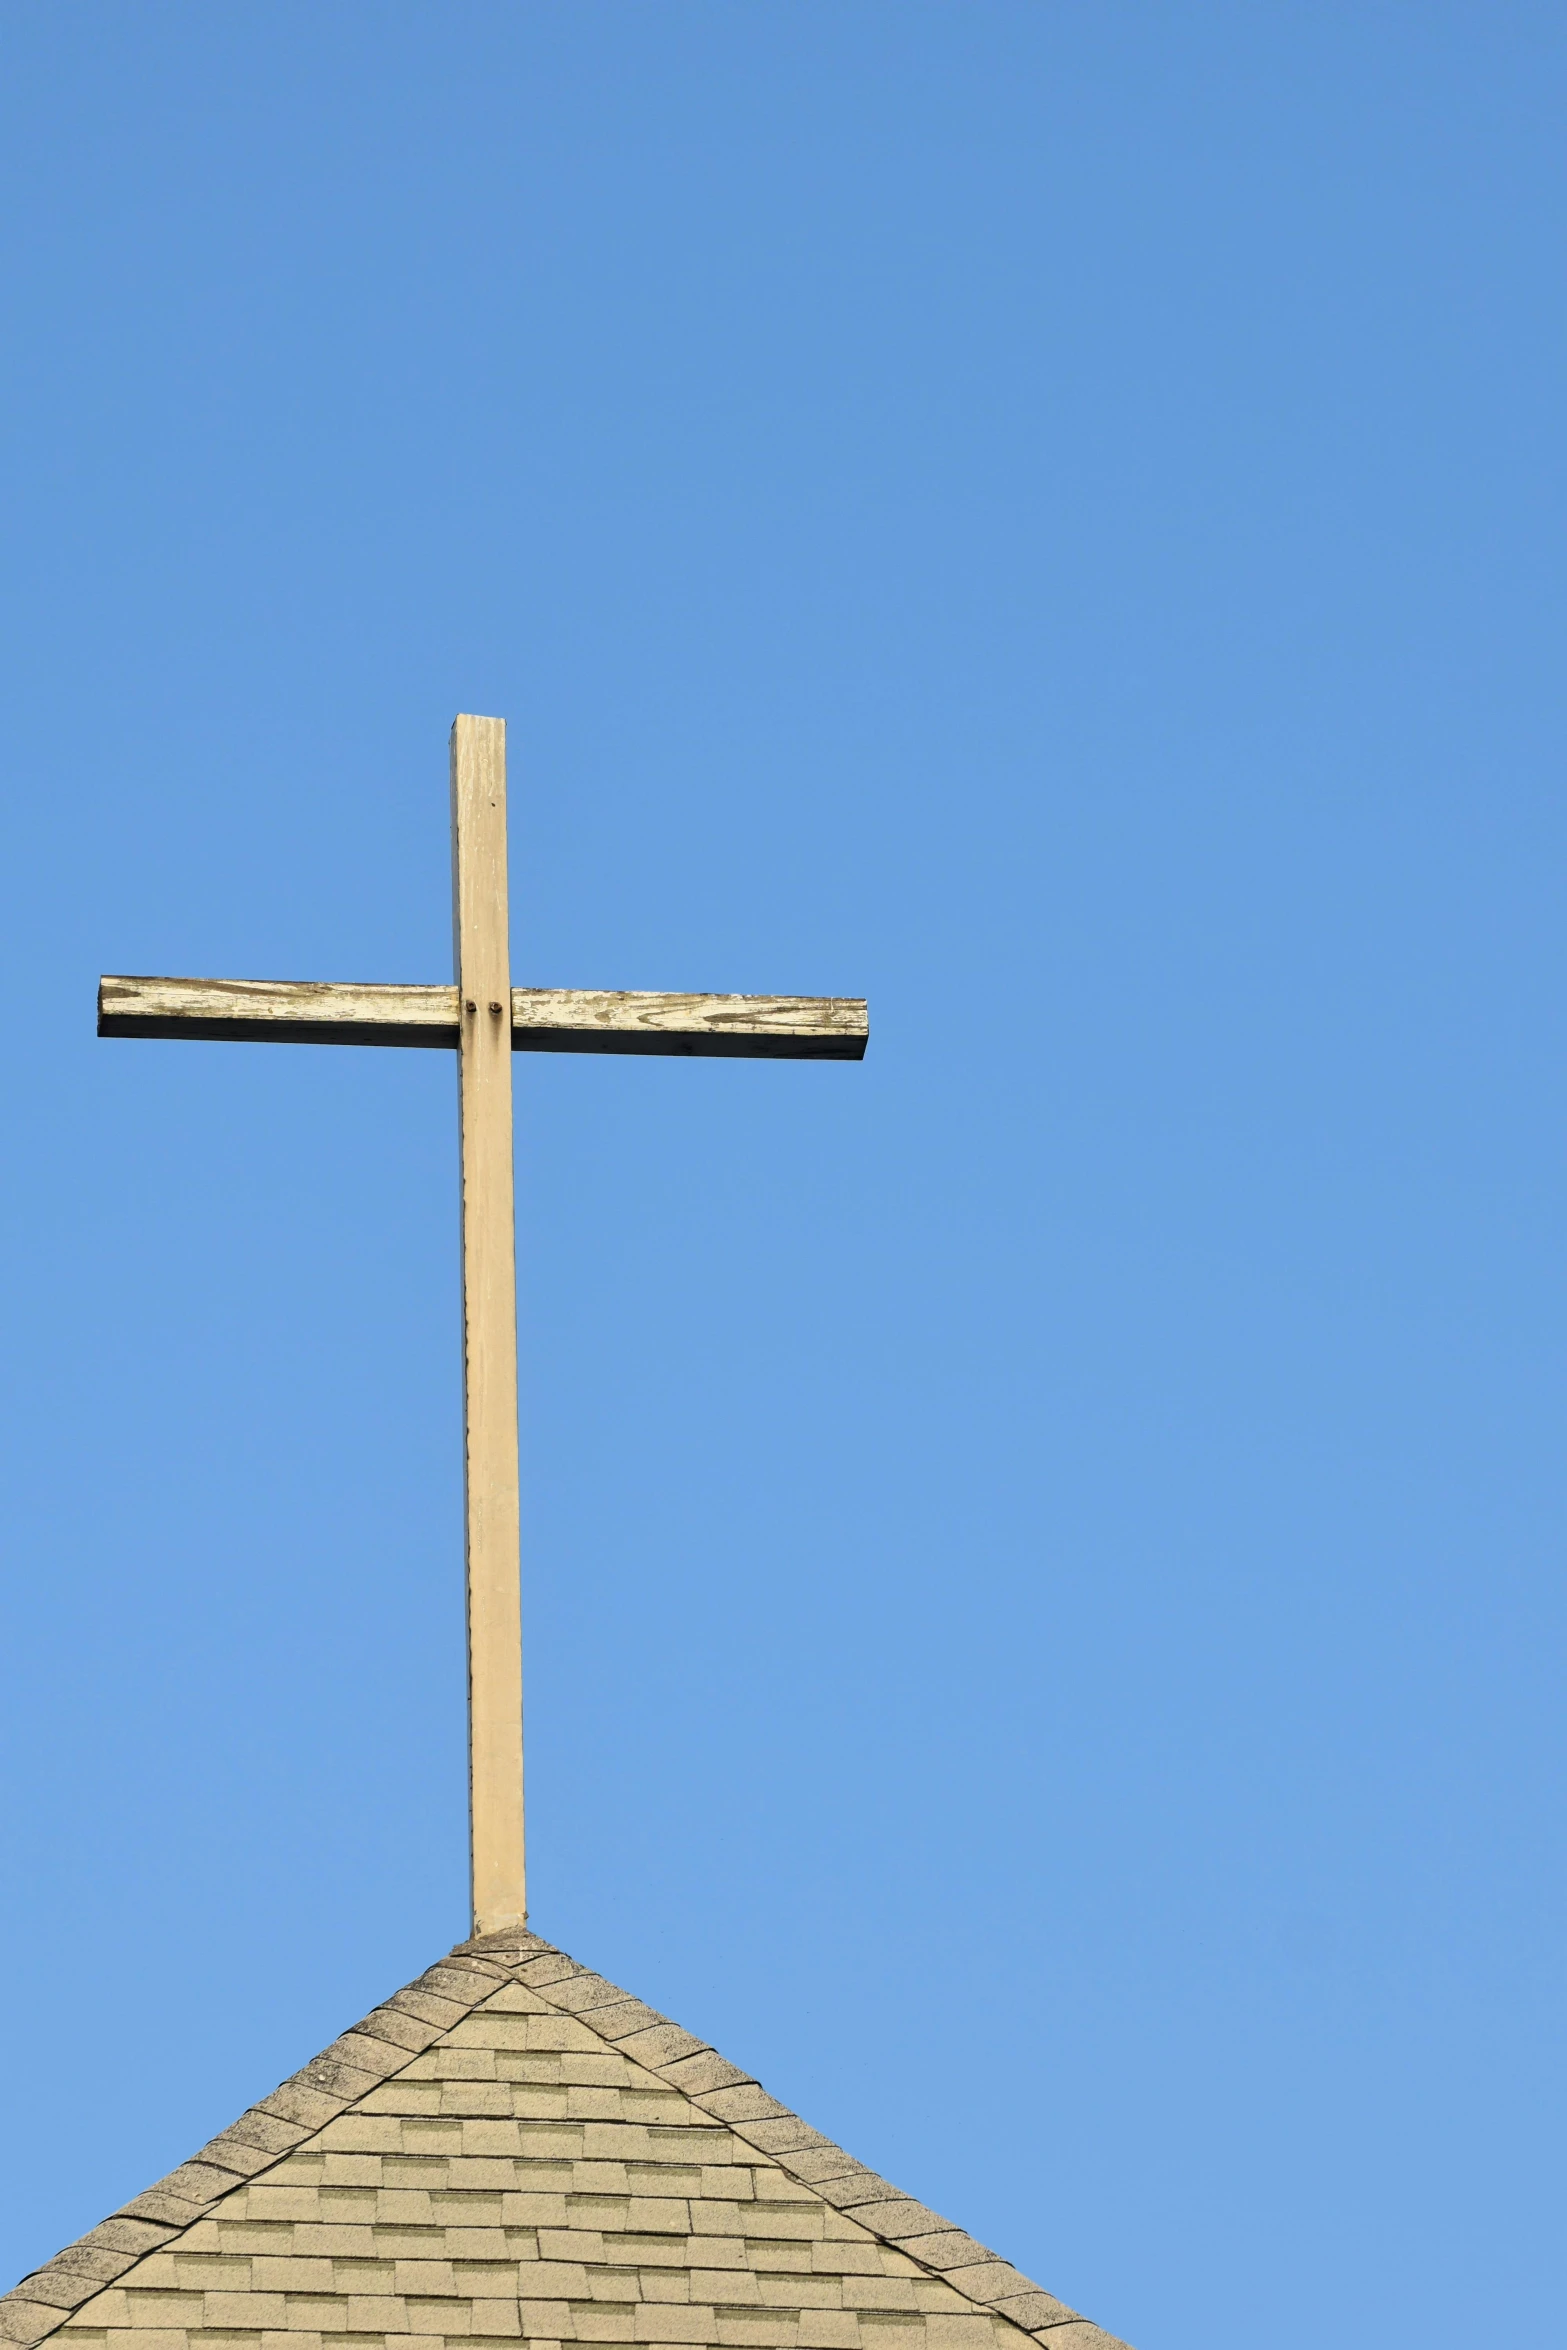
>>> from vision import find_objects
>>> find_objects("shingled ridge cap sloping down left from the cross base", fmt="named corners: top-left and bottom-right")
top-left (0, 1936), bottom-right (550, 2350)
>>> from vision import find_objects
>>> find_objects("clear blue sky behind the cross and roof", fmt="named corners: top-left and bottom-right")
top-left (0, 0), bottom-right (1567, 2350)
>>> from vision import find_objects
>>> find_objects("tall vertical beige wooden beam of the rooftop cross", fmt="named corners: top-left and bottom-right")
top-left (451, 717), bottom-right (529, 1934)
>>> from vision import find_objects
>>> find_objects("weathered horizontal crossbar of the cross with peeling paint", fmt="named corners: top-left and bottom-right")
top-left (99, 978), bottom-right (869, 1060)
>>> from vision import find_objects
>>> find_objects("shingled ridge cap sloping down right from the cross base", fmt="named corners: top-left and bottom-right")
top-left (451, 1932), bottom-right (1128, 2350)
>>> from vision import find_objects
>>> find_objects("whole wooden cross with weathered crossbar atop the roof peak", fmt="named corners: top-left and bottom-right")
top-left (99, 717), bottom-right (869, 1934)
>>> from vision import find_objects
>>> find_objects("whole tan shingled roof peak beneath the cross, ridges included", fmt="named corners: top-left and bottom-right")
top-left (0, 1934), bottom-right (1125, 2350)
